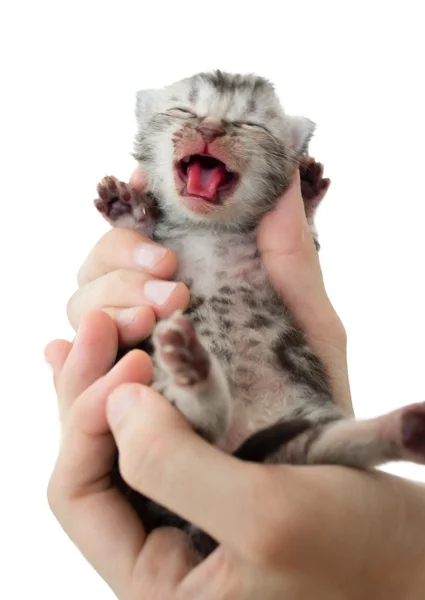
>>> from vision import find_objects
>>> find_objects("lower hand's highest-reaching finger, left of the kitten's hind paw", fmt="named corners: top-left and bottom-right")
top-left (56, 311), bottom-right (118, 420)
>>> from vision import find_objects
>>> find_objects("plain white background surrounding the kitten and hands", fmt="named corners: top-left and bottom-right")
top-left (0, 0), bottom-right (425, 600)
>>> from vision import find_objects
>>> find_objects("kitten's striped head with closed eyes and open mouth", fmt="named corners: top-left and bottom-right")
top-left (135, 72), bottom-right (314, 226)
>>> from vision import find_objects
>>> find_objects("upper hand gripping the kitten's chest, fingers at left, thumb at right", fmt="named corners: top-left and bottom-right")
top-left (67, 168), bottom-right (352, 413)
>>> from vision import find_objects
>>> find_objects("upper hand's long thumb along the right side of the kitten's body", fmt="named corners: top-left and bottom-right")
top-left (258, 171), bottom-right (351, 412)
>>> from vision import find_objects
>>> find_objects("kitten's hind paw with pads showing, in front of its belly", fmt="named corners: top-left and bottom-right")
top-left (153, 311), bottom-right (211, 388)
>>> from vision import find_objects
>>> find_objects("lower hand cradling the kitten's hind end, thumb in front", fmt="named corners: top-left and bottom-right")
top-left (46, 312), bottom-right (425, 600)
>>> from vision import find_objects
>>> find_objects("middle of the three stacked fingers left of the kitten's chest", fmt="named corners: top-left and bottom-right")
top-left (67, 269), bottom-right (189, 329)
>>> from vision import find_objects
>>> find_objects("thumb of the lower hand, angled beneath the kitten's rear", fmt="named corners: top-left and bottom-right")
top-left (107, 385), bottom-right (272, 548)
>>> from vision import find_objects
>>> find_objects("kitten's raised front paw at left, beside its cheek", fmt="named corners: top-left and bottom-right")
top-left (94, 176), bottom-right (152, 235)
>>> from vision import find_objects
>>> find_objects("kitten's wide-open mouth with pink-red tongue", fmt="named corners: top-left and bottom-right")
top-left (176, 154), bottom-right (238, 204)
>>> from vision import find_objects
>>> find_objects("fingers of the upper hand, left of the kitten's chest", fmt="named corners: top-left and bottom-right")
top-left (67, 166), bottom-right (189, 346)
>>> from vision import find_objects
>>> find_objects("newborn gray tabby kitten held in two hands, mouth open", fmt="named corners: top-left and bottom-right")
top-left (95, 71), bottom-right (425, 556)
